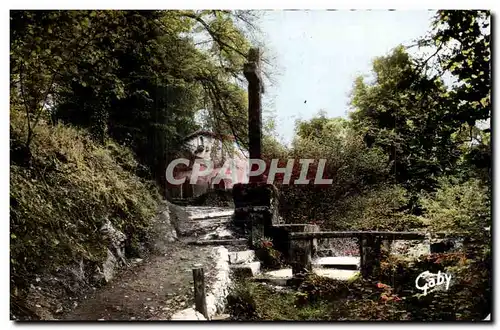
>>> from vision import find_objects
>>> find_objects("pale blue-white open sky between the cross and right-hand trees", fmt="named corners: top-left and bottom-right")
top-left (260, 10), bottom-right (433, 144)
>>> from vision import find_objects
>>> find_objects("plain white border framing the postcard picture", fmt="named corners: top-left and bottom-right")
top-left (0, 0), bottom-right (500, 329)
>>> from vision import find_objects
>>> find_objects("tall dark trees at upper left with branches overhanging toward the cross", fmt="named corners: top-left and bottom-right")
top-left (11, 10), bottom-right (266, 186)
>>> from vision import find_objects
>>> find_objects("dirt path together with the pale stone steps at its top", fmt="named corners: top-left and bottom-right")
top-left (60, 201), bottom-right (238, 321)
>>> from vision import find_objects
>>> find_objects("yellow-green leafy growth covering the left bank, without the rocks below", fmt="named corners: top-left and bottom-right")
top-left (10, 109), bottom-right (158, 288)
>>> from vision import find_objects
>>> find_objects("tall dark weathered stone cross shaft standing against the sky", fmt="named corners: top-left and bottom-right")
top-left (243, 48), bottom-right (263, 182)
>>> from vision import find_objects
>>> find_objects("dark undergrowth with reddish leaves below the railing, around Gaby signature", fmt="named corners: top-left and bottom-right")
top-left (228, 253), bottom-right (491, 321)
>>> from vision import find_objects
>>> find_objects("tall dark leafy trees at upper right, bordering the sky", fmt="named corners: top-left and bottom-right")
top-left (351, 10), bottom-right (491, 194)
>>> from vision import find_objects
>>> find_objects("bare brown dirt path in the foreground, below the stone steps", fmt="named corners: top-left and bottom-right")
top-left (62, 241), bottom-right (211, 320)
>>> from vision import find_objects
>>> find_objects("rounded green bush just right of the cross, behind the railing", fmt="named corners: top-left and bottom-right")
top-left (280, 114), bottom-right (389, 228)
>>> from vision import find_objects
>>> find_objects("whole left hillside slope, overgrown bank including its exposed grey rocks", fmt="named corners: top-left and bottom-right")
top-left (10, 109), bottom-right (159, 319)
